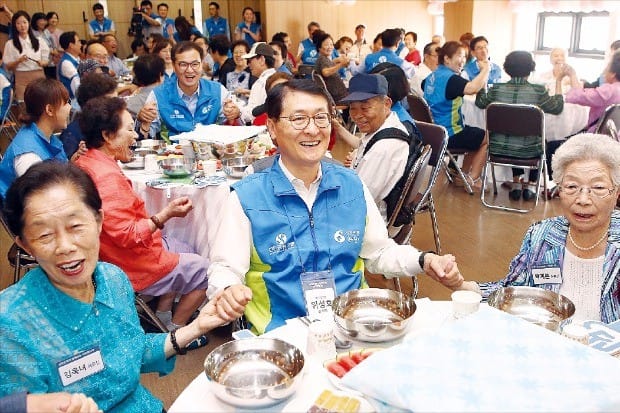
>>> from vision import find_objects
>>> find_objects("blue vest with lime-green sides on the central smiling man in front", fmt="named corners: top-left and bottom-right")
top-left (232, 159), bottom-right (366, 334)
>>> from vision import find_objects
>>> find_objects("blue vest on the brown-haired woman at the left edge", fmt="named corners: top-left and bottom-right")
top-left (0, 122), bottom-right (68, 198)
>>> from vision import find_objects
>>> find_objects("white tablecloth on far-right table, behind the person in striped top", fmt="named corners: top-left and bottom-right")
top-left (461, 95), bottom-right (590, 142)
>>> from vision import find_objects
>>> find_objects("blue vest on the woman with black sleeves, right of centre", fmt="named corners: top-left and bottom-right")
top-left (424, 65), bottom-right (463, 136)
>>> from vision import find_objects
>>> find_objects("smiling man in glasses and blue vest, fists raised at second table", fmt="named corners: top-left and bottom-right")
top-left (138, 42), bottom-right (240, 138)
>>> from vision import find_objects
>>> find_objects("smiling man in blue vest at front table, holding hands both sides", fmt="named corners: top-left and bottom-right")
top-left (207, 79), bottom-right (463, 334)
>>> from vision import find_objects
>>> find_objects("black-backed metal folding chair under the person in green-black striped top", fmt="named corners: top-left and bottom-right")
top-left (480, 102), bottom-right (547, 213)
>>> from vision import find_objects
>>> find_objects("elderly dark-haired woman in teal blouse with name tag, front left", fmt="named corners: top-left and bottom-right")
top-left (0, 162), bottom-right (229, 412)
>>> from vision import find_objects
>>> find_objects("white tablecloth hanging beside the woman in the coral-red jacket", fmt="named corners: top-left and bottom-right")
top-left (123, 169), bottom-right (234, 258)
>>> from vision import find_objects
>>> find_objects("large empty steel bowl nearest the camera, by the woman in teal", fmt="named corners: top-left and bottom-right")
top-left (204, 338), bottom-right (304, 409)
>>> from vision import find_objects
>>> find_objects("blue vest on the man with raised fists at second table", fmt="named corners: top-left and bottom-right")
top-left (153, 78), bottom-right (222, 136)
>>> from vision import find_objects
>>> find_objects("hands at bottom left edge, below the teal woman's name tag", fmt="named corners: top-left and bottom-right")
top-left (26, 393), bottom-right (102, 413)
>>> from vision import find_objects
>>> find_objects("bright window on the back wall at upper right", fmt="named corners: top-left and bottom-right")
top-left (536, 12), bottom-right (610, 59)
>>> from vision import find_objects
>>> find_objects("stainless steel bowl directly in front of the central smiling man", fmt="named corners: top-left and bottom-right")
top-left (332, 288), bottom-right (416, 343)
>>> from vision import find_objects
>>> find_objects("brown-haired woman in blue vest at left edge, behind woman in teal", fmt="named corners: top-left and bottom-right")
top-left (0, 78), bottom-right (71, 198)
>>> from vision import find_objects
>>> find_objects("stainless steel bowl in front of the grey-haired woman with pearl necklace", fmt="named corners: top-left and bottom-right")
top-left (488, 287), bottom-right (575, 331)
